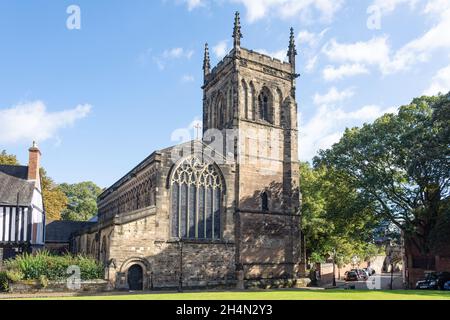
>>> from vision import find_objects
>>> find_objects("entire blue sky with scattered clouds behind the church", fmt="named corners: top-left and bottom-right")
top-left (0, 0), bottom-right (450, 187)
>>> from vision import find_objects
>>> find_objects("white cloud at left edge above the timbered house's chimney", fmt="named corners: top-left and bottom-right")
top-left (0, 101), bottom-right (92, 144)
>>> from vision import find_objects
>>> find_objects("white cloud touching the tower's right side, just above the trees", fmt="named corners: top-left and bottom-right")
top-left (299, 105), bottom-right (396, 161)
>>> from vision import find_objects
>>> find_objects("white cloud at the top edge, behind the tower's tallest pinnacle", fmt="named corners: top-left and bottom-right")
top-left (230, 0), bottom-right (344, 22)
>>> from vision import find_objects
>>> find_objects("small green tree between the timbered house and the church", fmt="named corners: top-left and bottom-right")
top-left (59, 182), bottom-right (102, 221)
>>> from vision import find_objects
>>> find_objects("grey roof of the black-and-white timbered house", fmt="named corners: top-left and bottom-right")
top-left (0, 165), bottom-right (35, 206)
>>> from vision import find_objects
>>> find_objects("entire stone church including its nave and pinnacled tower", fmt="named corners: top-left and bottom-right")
top-left (71, 13), bottom-right (305, 290)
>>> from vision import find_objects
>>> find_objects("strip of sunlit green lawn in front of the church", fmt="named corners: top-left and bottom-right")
top-left (22, 290), bottom-right (450, 300)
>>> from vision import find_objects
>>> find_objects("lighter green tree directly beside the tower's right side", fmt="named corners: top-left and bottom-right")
top-left (300, 163), bottom-right (378, 266)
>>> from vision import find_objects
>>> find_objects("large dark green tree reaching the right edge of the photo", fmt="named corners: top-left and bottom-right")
top-left (314, 95), bottom-right (450, 254)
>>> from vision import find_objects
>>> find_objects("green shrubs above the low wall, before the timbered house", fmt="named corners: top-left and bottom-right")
top-left (5, 251), bottom-right (103, 280)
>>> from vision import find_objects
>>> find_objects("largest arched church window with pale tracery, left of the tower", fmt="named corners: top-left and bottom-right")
top-left (170, 157), bottom-right (223, 240)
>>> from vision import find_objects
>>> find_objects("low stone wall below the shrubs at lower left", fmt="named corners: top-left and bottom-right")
top-left (9, 280), bottom-right (112, 293)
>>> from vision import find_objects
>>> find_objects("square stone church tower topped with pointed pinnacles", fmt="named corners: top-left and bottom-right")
top-left (203, 13), bottom-right (304, 278)
